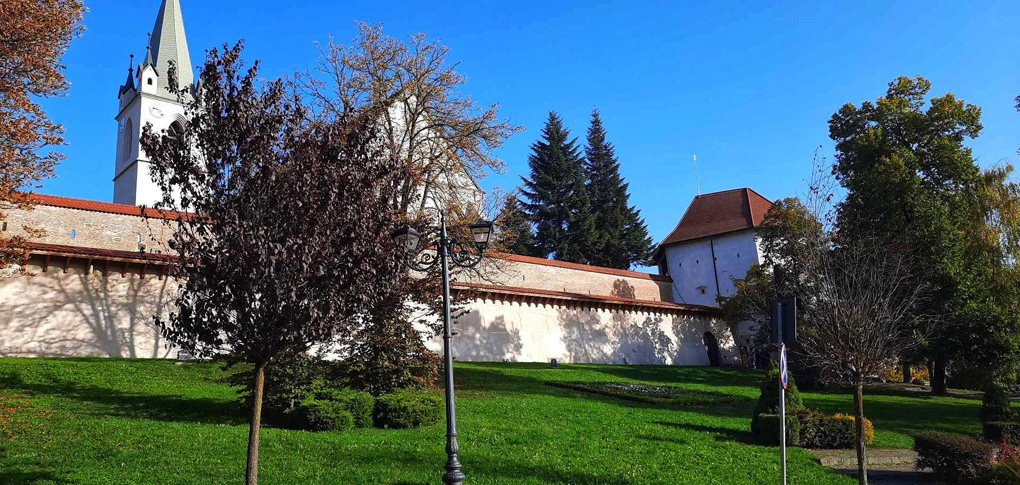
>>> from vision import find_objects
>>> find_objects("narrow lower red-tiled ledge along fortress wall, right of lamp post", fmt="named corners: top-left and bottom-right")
top-left (452, 282), bottom-right (722, 313)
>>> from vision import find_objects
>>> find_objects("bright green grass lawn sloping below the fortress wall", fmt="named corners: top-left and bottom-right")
top-left (0, 358), bottom-right (980, 484)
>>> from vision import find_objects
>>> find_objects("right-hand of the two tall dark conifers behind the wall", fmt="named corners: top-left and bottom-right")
top-left (584, 109), bottom-right (655, 270)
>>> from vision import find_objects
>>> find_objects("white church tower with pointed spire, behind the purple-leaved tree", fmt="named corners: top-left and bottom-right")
top-left (113, 0), bottom-right (195, 205)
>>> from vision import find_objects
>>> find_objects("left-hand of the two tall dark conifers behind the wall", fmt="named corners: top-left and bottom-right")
top-left (521, 111), bottom-right (596, 263)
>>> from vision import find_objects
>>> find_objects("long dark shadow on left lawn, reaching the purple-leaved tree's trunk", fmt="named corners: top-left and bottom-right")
top-left (0, 374), bottom-right (247, 424)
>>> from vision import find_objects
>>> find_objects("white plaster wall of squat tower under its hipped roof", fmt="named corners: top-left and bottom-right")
top-left (666, 230), bottom-right (761, 306)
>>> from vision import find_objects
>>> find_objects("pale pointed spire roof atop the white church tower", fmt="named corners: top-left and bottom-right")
top-left (146, 0), bottom-right (195, 98)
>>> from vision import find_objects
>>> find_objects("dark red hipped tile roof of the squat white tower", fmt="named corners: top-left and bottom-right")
top-left (660, 188), bottom-right (772, 247)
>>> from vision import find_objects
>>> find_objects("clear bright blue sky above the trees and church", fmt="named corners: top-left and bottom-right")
top-left (41, 0), bottom-right (1020, 254)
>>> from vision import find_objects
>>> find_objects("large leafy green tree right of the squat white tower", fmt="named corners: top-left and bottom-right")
top-left (829, 77), bottom-right (1010, 393)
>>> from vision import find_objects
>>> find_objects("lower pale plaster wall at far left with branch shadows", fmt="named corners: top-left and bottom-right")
top-left (0, 257), bottom-right (176, 358)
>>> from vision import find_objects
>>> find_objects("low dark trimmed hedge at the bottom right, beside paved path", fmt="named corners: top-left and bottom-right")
top-left (914, 431), bottom-right (996, 484)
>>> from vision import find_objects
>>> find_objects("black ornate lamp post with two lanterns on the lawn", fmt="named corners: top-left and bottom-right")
top-left (393, 213), bottom-right (493, 485)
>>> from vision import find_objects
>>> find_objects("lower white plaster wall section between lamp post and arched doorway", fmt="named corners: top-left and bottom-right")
top-left (427, 300), bottom-right (740, 366)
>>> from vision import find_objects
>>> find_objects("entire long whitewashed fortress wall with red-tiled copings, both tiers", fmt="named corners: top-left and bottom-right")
top-left (0, 196), bottom-right (737, 365)
